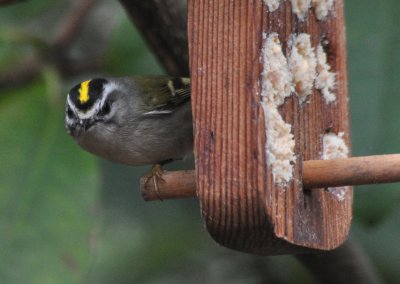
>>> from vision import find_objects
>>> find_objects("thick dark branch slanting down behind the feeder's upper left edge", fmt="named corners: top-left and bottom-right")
top-left (120, 0), bottom-right (189, 76)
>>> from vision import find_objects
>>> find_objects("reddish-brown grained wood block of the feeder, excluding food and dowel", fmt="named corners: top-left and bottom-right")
top-left (188, 0), bottom-right (352, 254)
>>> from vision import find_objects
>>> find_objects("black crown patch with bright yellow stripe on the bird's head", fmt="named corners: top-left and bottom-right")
top-left (69, 78), bottom-right (107, 111)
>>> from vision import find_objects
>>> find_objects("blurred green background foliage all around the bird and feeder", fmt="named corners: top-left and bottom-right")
top-left (0, 0), bottom-right (400, 283)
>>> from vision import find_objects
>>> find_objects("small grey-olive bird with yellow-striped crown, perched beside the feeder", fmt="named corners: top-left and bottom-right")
top-left (65, 76), bottom-right (193, 166)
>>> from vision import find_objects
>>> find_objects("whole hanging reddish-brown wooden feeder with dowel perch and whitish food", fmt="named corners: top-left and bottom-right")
top-left (142, 0), bottom-right (400, 254)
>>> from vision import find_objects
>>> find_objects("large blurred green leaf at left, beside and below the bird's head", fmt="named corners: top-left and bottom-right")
top-left (0, 82), bottom-right (99, 283)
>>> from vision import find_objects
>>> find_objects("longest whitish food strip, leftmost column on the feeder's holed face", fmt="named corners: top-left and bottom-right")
top-left (261, 33), bottom-right (295, 184)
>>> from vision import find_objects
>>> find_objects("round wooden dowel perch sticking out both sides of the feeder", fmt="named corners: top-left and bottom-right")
top-left (140, 154), bottom-right (400, 201)
